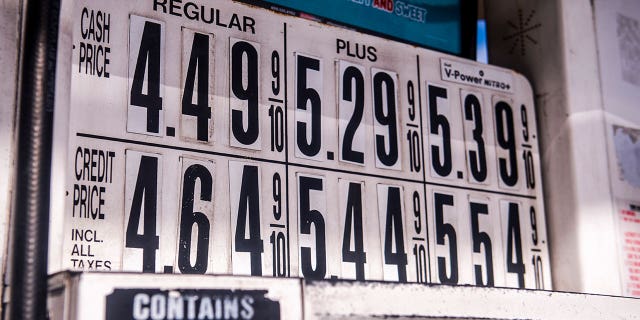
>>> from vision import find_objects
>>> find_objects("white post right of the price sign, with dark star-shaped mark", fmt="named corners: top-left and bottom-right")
top-left (485, 0), bottom-right (621, 294)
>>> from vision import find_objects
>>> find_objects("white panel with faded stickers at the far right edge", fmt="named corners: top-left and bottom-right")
top-left (594, 0), bottom-right (640, 297)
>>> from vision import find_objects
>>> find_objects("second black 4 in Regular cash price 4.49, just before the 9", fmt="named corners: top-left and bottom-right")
top-left (182, 33), bottom-right (211, 141)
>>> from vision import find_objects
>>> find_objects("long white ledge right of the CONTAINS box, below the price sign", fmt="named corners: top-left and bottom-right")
top-left (303, 282), bottom-right (640, 320)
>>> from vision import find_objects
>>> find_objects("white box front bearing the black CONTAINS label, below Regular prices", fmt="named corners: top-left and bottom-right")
top-left (47, 273), bottom-right (303, 320)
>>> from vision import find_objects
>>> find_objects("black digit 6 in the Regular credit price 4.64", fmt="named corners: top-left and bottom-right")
top-left (178, 164), bottom-right (213, 274)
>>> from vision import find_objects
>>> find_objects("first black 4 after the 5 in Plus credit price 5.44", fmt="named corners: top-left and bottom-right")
top-left (342, 183), bottom-right (367, 280)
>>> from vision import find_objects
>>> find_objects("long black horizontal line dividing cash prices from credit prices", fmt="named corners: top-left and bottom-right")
top-left (76, 132), bottom-right (536, 200)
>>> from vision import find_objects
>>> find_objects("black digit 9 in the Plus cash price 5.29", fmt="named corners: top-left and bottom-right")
top-left (373, 72), bottom-right (398, 167)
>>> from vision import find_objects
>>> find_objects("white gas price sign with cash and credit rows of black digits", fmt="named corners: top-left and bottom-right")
top-left (57, 0), bottom-right (551, 289)
